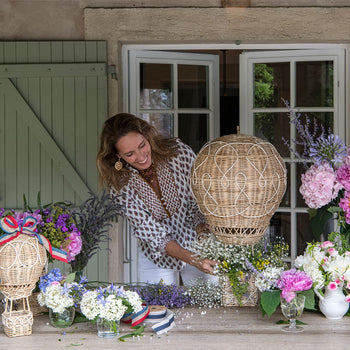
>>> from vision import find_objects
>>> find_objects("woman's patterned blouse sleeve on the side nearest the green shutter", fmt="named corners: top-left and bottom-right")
top-left (116, 189), bottom-right (173, 257)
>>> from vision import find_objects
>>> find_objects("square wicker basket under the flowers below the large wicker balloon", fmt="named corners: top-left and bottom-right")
top-left (220, 275), bottom-right (259, 306)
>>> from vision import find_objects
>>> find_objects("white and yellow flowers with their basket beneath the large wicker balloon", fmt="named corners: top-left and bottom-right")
top-left (195, 235), bottom-right (288, 306)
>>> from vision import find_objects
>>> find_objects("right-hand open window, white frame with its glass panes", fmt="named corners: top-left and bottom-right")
top-left (240, 49), bottom-right (345, 262)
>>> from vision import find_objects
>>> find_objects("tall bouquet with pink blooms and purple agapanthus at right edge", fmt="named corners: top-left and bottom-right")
top-left (285, 105), bottom-right (350, 240)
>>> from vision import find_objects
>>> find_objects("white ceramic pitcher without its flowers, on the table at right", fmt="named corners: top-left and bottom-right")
top-left (315, 285), bottom-right (349, 320)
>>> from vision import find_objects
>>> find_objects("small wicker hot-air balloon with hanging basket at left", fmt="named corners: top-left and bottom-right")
top-left (0, 219), bottom-right (47, 337)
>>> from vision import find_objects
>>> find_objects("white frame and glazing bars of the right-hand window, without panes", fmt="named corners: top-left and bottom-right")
top-left (240, 49), bottom-right (346, 262)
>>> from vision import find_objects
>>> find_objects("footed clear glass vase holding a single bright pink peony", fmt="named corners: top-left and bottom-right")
top-left (281, 295), bottom-right (305, 333)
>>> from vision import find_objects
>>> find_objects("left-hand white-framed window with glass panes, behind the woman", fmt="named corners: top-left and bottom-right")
top-left (124, 50), bottom-right (220, 282)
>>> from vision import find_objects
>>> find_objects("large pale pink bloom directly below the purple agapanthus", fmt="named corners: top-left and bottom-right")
top-left (300, 162), bottom-right (342, 209)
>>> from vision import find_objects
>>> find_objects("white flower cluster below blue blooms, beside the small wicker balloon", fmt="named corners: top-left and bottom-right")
top-left (38, 284), bottom-right (74, 313)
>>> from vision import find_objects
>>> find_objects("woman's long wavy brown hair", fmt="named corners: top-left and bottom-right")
top-left (96, 113), bottom-right (178, 192)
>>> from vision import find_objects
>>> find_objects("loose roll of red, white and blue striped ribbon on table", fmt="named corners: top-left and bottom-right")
top-left (122, 304), bottom-right (175, 335)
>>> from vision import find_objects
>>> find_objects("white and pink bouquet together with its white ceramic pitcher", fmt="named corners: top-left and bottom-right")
top-left (295, 232), bottom-right (350, 319)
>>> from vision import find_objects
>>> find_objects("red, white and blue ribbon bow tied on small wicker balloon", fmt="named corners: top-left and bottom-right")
top-left (0, 215), bottom-right (68, 263)
